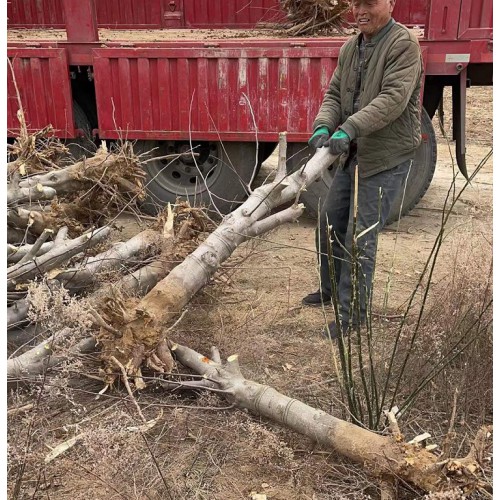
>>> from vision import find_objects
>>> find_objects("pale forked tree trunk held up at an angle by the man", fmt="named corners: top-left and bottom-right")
top-left (102, 148), bottom-right (335, 375)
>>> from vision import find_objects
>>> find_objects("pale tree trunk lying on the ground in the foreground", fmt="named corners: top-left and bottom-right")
top-left (172, 344), bottom-right (488, 492)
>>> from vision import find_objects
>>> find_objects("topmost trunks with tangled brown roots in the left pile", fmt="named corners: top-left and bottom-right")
top-left (7, 139), bottom-right (145, 232)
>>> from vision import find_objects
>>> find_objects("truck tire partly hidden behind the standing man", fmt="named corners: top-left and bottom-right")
top-left (287, 109), bottom-right (437, 225)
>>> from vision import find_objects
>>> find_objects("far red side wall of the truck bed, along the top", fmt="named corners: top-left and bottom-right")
top-left (7, 0), bottom-right (460, 28)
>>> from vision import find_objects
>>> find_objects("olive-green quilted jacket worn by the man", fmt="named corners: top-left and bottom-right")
top-left (313, 19), bottom-right (423, 177)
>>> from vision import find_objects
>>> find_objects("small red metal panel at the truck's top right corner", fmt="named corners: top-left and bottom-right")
top-left (459, 0), bottom-right (493, 40)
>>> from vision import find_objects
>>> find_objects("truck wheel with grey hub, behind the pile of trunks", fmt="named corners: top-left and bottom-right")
top-left (139, 141), bottom-right (256, 214)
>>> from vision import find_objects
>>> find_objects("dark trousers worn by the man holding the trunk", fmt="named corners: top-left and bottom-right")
top-left (316, 157), bottom-right (411, 324)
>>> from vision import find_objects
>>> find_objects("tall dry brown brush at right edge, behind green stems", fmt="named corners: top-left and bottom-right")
top-left (392, 224), bottom-right (493, 432)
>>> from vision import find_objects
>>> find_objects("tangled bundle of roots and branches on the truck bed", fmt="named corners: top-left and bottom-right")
top-left (280, 0), bottom-right (349, 36)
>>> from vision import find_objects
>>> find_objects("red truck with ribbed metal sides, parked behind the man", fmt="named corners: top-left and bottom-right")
top-left (7, 0), bottom-right (493, 219)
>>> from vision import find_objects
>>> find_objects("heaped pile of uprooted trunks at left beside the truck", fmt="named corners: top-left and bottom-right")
top-left (7, 128), bottom-right (211, 378)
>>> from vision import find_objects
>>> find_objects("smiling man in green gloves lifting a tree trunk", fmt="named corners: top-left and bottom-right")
top-left (302, 0), bottom-right (423, 338)
